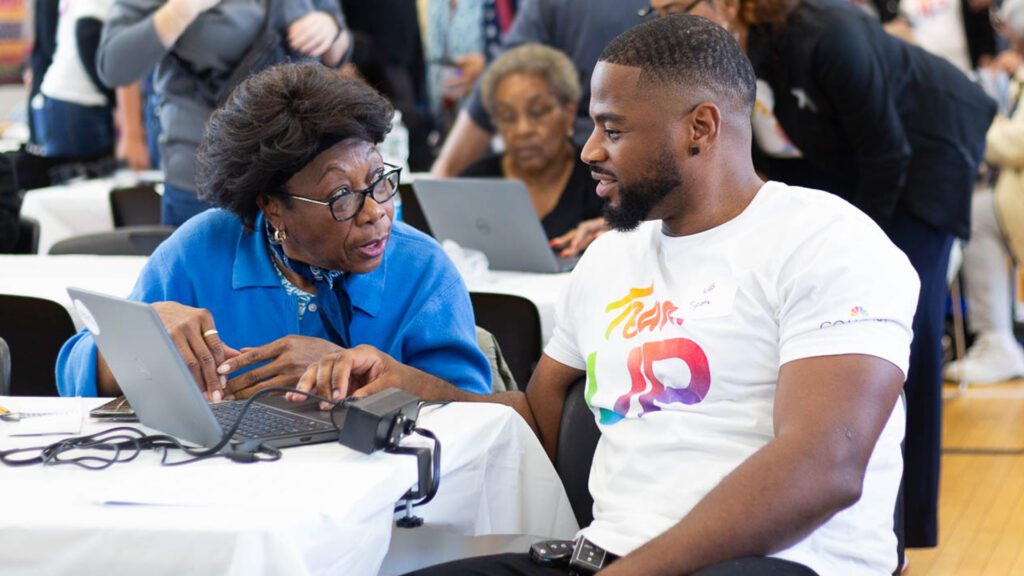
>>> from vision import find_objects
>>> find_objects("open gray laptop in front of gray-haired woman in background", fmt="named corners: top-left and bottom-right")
top-left (413, 178), bottom-right (579, 273)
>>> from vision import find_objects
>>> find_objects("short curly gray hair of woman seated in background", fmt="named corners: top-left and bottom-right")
top-left (480, 44), bottom-right (580, 116)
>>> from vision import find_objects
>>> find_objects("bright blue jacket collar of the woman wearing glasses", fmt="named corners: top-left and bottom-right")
top-left (231, 214), bottom-right (387, 316)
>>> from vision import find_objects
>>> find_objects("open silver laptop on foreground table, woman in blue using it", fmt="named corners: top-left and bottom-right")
top-left (68, 288), bottom-right (344, 448)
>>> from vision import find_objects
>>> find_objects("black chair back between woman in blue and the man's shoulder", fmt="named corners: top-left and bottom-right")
top-left (469, 292), bottom-right (543, 389)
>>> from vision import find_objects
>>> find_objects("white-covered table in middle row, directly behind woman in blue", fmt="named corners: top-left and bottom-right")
top-left (0, 254), bottom-right (569, 342)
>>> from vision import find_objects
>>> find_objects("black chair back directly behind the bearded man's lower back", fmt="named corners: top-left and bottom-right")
top-left (555, 378), bottom-right (601, 528)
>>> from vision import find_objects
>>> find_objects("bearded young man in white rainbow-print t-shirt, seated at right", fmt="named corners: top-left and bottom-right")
top-left (303, 15), bottom-right (919, 576)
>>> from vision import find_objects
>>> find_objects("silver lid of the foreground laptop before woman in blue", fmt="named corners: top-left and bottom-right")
top-left (68, 288), bottom-right (223, 447)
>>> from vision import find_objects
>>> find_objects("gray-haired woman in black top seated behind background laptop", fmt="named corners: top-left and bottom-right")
top-left (460, 44), bottom-right (605, 256)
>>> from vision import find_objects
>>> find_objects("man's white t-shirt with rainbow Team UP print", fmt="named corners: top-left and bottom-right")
top-left (545, 182), bottom-right (920, 576)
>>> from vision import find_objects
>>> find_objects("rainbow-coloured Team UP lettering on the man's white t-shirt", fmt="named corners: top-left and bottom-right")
top-left (585, 285), bottom-right (711, 424)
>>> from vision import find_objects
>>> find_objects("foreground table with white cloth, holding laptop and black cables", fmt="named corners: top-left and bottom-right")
top-left (0, 398), bottom-right (578, 576)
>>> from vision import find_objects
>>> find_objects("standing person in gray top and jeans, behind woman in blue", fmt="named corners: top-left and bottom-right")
top-left (97, 0), bottom-right (350, 225)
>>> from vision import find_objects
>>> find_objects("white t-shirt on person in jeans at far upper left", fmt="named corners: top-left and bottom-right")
top-left (39, 0), bottom-right (114, 106)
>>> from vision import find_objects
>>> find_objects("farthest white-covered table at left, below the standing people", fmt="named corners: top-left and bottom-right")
top-left (22, 171), bottom-right (163, 254)
